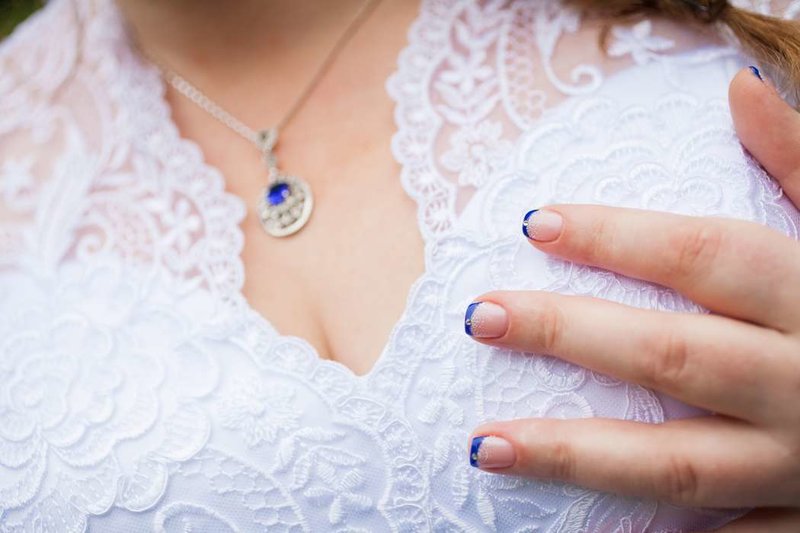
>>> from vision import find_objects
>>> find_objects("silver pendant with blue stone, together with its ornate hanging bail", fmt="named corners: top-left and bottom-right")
top-left (255, 128), bottom-right (314, 237)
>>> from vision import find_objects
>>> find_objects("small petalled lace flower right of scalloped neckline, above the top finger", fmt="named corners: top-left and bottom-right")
top-left (442, 121), bottom-right (511, 187)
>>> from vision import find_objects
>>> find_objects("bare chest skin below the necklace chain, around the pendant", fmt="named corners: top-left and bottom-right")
top-left (163, 2), bottom-right (423, 374)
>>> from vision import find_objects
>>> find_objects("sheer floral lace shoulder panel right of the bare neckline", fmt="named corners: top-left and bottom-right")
top-left (388, 0), bottom-right (800, 239)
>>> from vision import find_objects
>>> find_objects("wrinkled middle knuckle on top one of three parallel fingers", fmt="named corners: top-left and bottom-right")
top-left (667, 221), bottom-right (723, 277)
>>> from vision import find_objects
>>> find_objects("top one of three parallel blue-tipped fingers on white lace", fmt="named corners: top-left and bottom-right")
top-left (526, 205), bottom-right (800, 331)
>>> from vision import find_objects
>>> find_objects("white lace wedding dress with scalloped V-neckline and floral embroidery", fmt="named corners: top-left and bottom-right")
top-left (0, 0), bottom-right (800, 533)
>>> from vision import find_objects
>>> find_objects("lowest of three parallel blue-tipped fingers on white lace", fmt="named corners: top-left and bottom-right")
top-left (469, 417), bottom-right (800, 508)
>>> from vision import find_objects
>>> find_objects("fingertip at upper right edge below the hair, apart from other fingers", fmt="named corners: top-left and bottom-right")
top-left (729, 69), bottom-right (800, 205)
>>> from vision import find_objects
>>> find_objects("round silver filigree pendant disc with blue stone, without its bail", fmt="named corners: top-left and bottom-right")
top-left (258, 173), bottom-right (314, 237)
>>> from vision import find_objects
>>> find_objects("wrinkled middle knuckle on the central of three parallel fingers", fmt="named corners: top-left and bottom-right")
top-left (639, 329), bottom-right (691, 392)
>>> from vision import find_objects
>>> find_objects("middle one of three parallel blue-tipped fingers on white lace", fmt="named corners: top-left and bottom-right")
top-left (467, 291), bottom-right (800, 422)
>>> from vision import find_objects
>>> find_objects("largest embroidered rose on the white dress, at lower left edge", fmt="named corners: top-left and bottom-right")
top-left (0, 260), bottom-right (215, 528)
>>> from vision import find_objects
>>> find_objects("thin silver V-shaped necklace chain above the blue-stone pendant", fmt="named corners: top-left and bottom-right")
top-left (156, 0), bottom-right (382, 159)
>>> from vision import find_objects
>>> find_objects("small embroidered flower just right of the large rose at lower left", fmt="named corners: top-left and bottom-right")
top-left (220, 379), bottom-right (301, 447)
